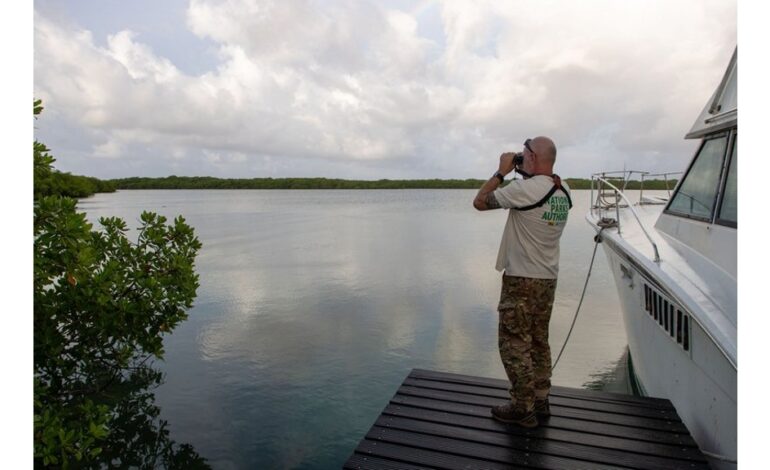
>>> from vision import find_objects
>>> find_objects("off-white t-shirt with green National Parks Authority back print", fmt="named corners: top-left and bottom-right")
top-left (494, 175), bottom-right (569, 279)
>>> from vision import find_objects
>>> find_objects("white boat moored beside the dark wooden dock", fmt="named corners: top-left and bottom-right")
top-left (586, 48), bottom-right (738, 469)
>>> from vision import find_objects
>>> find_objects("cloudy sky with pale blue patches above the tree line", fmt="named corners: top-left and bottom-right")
top-left (33, 0), bottom-right (737, 179)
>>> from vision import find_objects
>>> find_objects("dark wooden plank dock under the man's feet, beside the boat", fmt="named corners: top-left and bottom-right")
top-left (344, 369), bottom-right (709, 470)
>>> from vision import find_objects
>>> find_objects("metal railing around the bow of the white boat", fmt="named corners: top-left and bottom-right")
top-left (591, 170), bottom-right (660, 263)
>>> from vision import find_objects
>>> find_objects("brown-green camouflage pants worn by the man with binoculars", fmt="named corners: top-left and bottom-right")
top-left (497, 275), bottom-right (556, 411)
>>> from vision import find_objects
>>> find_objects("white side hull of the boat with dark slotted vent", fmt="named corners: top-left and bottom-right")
top-left (603, 237), bottom-right (737, 469)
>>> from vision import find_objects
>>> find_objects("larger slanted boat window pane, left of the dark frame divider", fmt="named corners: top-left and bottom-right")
top-left (668, 135), bottom-right (727, 219)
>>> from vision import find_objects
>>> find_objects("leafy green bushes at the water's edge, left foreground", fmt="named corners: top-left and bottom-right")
top-left (35, 100), bottom-right (211, 469)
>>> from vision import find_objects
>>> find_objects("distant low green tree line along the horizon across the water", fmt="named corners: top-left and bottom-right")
top-left (107, 175), bottom-right (676, 189)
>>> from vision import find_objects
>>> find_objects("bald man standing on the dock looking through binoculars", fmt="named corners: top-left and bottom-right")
top-left (473, 137), bottom-right (572, 428)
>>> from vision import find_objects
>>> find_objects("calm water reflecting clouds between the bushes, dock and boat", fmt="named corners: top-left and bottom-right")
top-left (80, 190), bottom-right (626, 469)
